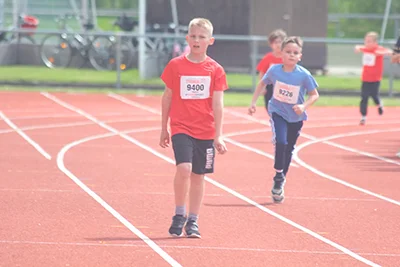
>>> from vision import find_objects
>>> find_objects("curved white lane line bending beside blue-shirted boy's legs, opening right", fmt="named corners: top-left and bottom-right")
top-left (293, 128), bottom-right (400, 206)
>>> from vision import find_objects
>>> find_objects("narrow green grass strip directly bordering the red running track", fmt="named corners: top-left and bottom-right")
top-left (0, 86), bottom-right (400, 107)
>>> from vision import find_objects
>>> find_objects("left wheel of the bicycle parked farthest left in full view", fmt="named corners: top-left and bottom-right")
top-left (40, 34), bottom-right (72, 69)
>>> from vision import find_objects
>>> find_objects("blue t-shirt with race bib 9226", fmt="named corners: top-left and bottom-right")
top-left (262, 64), bottom-right (318, 122)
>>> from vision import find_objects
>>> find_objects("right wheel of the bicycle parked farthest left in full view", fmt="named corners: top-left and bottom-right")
top-left (88, 36), bottom-right (115, 70)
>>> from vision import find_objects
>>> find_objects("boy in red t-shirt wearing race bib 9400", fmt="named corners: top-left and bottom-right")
top-left (160, 18), bottom-right (228, 238)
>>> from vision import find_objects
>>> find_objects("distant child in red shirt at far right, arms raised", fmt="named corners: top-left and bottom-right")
top-left (355, 32), bottom-right (392, 125)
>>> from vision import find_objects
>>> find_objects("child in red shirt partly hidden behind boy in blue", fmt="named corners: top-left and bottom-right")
top-left (257, 29), bottom-right (287, 111)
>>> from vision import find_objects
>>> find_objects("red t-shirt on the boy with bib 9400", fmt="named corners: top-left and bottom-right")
top-left (161, 55), bottom-right (228, 140)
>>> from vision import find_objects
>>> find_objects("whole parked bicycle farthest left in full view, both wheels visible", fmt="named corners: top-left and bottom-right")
top-left (40, 14), bottom-right (122, 71)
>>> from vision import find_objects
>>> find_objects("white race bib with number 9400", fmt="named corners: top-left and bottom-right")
top-left (181, 76), bottom-right (211, 99)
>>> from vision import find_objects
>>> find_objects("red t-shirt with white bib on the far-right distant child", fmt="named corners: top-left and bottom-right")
top-left (361, 46), bottom-right (384, 82)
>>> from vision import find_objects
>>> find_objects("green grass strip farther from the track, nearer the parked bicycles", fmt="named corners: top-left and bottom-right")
top-left (0, 66), bottom-right (400, 92)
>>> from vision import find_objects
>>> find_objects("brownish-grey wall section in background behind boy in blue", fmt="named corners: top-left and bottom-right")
top-left (250, 0), bottom-right (328, 70)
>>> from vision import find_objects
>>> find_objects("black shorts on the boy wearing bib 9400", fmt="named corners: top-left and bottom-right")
top-left (171, 133), bottom-right (215, 174)
